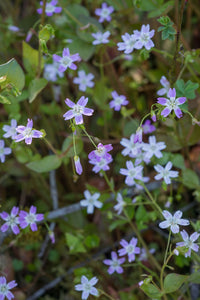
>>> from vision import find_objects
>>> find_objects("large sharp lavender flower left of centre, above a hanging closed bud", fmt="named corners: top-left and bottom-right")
top-left (63, 96), bottom-right (94, 125)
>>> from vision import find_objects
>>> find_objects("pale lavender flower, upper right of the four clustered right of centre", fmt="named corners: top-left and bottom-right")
top-left (143, 135), bottom-right (166, 159)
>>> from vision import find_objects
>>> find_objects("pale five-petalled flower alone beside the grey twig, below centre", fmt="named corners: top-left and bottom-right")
top-left (80, 190), bottom-right (103, 214)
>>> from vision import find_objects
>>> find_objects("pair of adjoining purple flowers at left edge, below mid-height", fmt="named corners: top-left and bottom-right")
top-left (0, 205), bottom-right (44, 234)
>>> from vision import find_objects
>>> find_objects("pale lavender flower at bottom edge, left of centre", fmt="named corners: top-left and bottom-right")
top-left (75, 275), bottom-right (99, 300)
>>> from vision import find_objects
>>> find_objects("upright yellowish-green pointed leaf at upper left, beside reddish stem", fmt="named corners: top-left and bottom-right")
top-left (22, 41), bottom-right (44, 77)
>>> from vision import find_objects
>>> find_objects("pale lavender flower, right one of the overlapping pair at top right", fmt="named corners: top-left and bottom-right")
top-left (134, 24), bottom-right (155, 50)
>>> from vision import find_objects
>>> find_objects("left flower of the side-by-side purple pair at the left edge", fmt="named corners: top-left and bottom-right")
top-left (0, 206), bottom-right (20, 234)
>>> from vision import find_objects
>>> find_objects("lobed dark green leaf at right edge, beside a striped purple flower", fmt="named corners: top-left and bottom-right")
top-left (175, 79), bottom-right (199, 99)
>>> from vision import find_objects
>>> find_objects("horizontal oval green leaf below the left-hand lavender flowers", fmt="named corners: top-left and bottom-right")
top-left (26, 155), bottom-right (62, 173)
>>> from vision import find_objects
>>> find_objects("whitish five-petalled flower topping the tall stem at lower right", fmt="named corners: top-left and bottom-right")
top-left (159, 210), bottom-right (190, 233)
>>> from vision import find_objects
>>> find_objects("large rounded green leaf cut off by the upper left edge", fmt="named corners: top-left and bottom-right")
top-left (0, 58), bottom-right (25, 90)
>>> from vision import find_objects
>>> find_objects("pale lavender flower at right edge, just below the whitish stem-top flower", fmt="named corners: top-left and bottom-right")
top-left (176, 230), bottom-right (199, 257)
